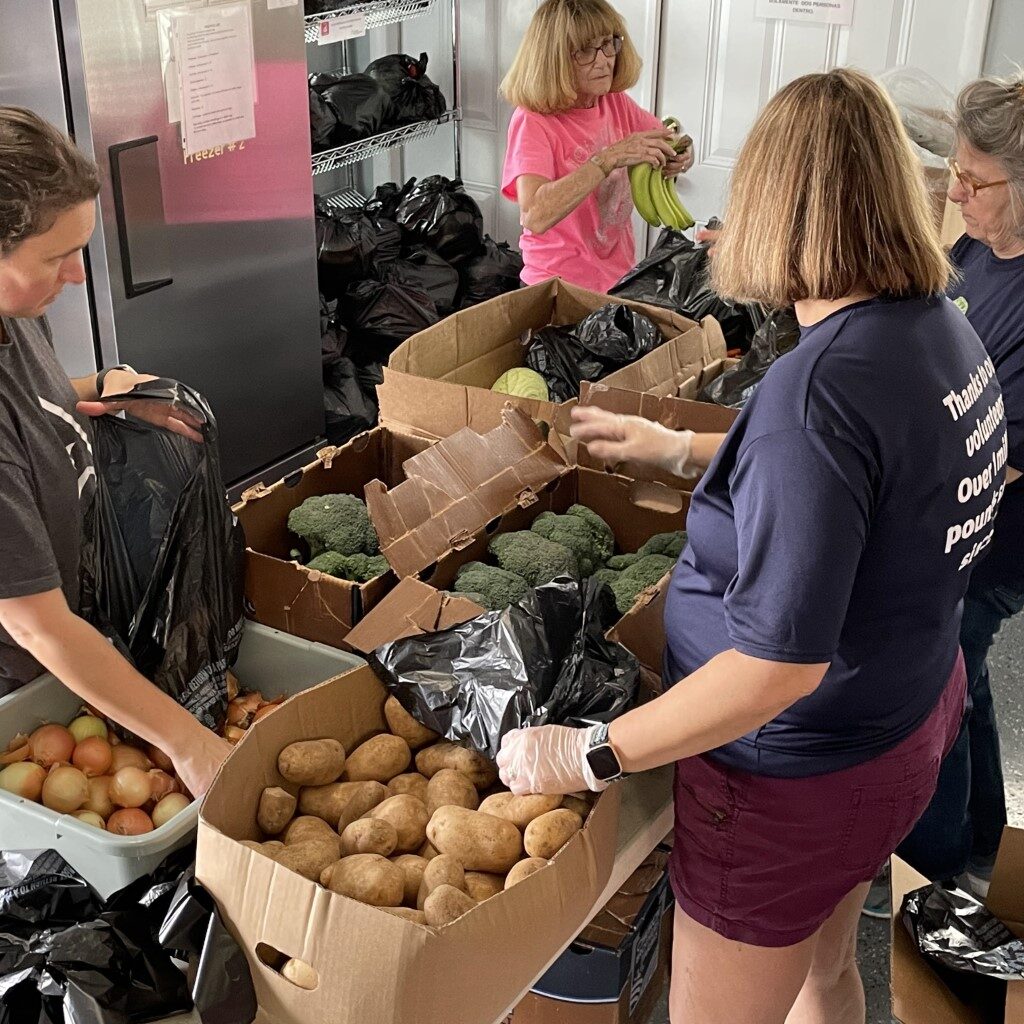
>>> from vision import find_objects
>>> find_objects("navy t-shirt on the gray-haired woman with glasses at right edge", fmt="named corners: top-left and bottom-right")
top-left (949, 234), bottom-right (1024, 588)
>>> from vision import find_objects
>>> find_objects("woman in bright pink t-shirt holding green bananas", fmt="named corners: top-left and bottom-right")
top-left (502, 0), bottom-right (693, 292)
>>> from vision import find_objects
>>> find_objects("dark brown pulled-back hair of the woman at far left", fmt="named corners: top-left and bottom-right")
top-left (0, 106), bottom-right (99, 257)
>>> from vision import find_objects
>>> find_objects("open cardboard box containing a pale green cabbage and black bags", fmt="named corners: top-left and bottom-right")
top-left (378, 279), bottom-right (725, 437)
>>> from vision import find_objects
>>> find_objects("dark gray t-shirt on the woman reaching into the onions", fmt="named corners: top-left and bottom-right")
top-left (0, 317), bottom-right (96, 695)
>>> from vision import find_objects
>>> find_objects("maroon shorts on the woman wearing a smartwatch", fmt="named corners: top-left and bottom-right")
top-left (670, 655), bottom-right (967, 946)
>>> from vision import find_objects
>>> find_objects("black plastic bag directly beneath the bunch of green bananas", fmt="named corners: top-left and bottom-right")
top-left (608, 220), bottom-right (754, 351)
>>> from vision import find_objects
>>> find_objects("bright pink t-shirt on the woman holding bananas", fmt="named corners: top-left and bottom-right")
top-left (502, 92), bottom-right (662, 292)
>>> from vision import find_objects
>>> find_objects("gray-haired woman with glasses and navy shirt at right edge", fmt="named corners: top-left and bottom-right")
top-left (900, 74), bottom-right (1024, 895)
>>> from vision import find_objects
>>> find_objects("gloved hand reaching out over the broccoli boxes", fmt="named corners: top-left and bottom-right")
top-left (569, 406), bottom-right (700, 477)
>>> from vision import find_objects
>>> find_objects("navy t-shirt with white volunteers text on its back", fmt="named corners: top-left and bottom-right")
top-left (666, 298), bottom-right (1006, 777)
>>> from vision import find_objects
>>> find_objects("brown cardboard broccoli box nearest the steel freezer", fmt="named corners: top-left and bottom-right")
top-left (234, 427), bottom-right (431, 647)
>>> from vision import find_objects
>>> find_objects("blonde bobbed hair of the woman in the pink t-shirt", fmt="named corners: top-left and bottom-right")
top-left (500, 0), bottom-right (643, 114)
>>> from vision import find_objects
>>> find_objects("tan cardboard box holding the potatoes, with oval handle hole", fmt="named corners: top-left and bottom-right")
top-left (196, 667), bottom-right (620, 1024)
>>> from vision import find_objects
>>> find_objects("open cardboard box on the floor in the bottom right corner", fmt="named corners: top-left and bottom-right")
top-left (891, 828), bottom-right (1024, 1024)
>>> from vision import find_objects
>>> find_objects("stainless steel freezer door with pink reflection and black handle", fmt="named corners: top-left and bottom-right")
top-left (70, 0), bottom-right (324, 481)
